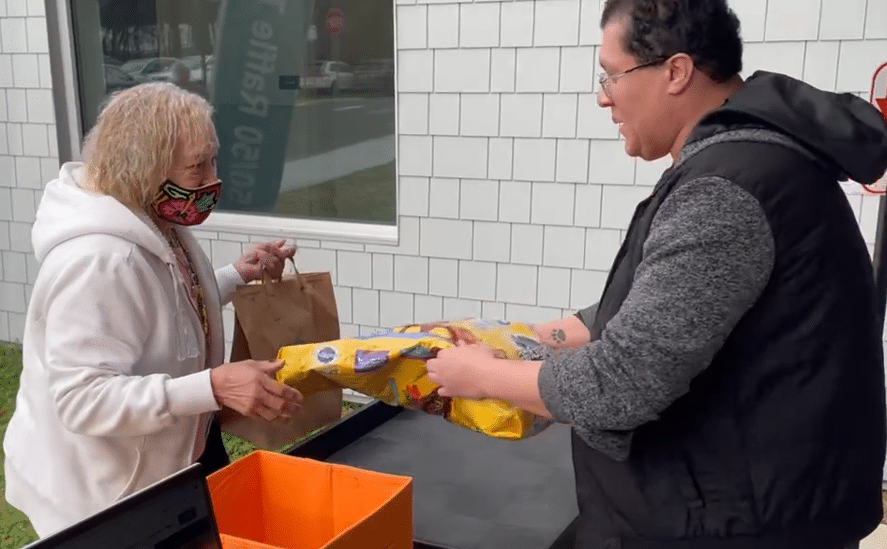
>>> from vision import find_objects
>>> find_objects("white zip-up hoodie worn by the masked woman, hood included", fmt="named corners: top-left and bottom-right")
top-left (3, 163), bottom-right (243, 537)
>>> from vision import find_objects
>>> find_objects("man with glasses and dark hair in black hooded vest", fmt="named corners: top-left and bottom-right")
top-left (428, 0), bottom-right (887, 549)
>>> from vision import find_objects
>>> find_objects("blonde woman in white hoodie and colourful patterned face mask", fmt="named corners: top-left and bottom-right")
top-left (3, 83), bottom-right (301, 537)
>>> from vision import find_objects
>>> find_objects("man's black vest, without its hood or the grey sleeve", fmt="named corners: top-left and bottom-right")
top-left (573, 130), bottom-right (887, 549)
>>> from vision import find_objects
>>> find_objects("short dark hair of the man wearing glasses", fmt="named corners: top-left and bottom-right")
top-left (601, 0), bottom-right (742, 82)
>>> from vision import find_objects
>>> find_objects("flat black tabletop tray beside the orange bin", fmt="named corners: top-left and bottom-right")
top-left (285, 401), bottom-right (577, 549)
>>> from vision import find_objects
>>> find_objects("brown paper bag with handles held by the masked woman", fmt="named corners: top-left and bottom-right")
top-left (220, 264), bottom-right (342, 450)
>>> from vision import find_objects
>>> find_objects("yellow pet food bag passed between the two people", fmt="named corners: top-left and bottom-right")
top-left (277, 319), bottom-right (550, 440)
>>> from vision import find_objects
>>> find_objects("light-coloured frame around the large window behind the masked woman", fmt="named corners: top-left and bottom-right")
top-left (44, 0), bottom-right (400, 245)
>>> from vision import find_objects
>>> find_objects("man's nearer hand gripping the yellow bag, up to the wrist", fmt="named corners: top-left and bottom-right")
top-left (425, 344), bottom-right (499, 399)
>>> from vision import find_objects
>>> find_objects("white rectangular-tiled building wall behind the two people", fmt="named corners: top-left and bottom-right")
top-left (0, 0), bottom-right (887, 346)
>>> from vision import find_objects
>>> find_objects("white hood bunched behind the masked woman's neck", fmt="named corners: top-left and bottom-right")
top-left (31, 162), bottom-right (174, 263)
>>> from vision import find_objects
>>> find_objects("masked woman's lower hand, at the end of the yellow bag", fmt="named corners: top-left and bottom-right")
top-left (210, 360), bottom-right (302, 423)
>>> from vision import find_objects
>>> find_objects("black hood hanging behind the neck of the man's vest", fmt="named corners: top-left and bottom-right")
top-left (687, 71), bottom-right (887, 185)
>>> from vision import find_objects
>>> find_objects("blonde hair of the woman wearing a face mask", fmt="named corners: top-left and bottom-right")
top-left (83, 82), bottom-right (218, 211)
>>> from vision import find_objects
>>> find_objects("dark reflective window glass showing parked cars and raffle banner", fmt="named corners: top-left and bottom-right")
top-left (71, 0), bottom-right (396, 224)
